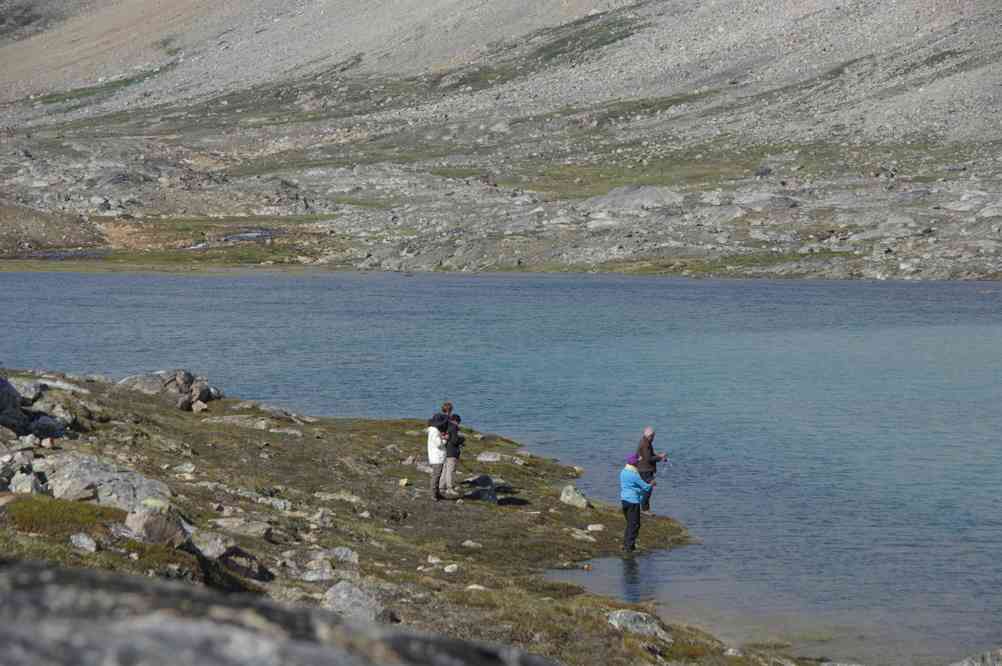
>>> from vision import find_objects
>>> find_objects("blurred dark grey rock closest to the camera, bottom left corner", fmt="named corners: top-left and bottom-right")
top-left (0, 561), bottom-right (551, 666)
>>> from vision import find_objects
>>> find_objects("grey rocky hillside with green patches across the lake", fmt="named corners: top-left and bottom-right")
top-left (0, 0), bottom-right (1002, 278)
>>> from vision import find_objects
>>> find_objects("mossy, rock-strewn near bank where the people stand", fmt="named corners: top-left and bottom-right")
top-left (0, 371), bottom-right (753, 664)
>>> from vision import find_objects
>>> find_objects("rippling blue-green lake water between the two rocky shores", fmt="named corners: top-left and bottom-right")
top-left (0, 273), bottom-right (1002, 665)
